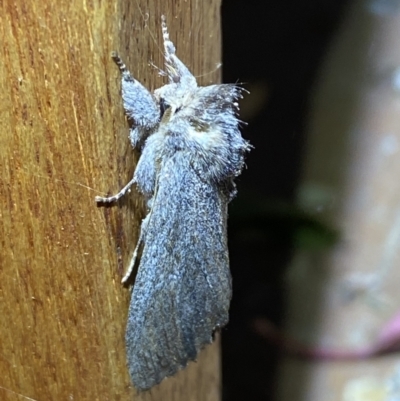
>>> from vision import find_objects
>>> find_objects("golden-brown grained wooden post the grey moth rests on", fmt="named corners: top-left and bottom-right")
top-left (0, 0), bottom-right (220, 401)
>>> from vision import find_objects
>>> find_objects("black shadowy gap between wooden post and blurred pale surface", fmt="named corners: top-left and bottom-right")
top-left (222, 0), bottom-right (349, 401)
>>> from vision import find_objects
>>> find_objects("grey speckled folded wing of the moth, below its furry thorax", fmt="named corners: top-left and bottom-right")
top-left (126, 152), bottom-right (231, 390)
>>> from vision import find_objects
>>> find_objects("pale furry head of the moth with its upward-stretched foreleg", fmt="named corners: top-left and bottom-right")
top-left (158, 17), bottom-right (242, 148)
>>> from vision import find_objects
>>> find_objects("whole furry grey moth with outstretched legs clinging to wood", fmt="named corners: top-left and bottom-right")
top-left (96, 18), bottom-right (250, 390)
